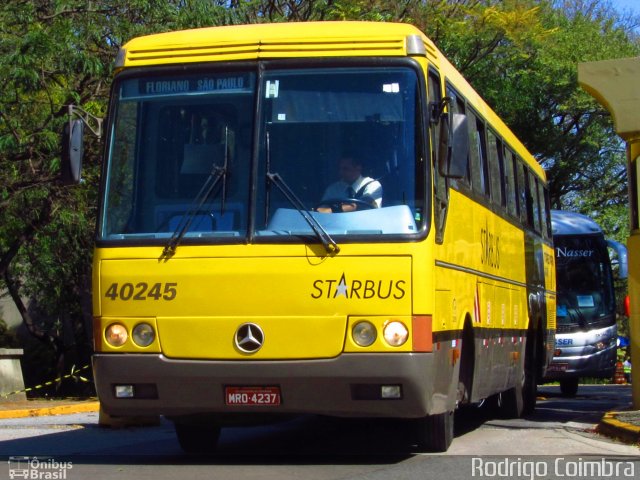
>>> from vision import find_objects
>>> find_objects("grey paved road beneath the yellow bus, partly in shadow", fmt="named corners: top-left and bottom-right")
top-left (0, 386), bottom-right (640, 480)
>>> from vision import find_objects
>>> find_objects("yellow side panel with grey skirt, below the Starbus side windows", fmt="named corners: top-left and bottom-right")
top-left (434, 189), bottom-right (527, 401)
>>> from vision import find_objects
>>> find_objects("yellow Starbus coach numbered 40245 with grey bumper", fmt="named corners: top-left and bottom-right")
top-left (63, 22), bottom-right (555, 452)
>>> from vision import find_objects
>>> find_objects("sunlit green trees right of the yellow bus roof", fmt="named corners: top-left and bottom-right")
top-left (410, 0), bottom-right (640, 240)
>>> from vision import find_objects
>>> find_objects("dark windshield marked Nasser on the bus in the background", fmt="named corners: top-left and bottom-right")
top-left (554, 235), bottom-right (615, 328)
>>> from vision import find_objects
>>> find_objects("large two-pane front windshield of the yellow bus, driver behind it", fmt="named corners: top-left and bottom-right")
top-left (99, 66), bottom-right (427, 244)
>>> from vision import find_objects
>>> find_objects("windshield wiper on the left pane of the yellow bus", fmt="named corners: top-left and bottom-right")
top-left (162, 128), bottom-right (229, 258)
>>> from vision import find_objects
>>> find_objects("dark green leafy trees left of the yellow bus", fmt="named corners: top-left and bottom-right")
top-left (0, 0), bottom-right (180, 394)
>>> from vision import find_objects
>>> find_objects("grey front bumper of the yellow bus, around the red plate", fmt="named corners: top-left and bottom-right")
top-left (93, 353), bottom-right (444, 418)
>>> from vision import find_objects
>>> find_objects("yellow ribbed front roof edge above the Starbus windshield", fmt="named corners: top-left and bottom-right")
top-left (117, 22), bottom-right (435, 67)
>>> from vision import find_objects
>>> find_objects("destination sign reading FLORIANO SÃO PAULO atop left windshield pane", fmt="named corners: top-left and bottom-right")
top-left (121, 73), bottom-right (253, 98)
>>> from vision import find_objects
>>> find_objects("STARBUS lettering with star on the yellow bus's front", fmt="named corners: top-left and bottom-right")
top-left (311, 273), bottom-right (407, 300)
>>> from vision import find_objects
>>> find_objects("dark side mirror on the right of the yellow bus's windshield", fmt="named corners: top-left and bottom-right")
top-left (438, 113), bottom-right (469, 178)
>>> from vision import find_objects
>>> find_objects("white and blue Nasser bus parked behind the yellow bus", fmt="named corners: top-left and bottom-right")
top-left (546, 210), bottom-right (627, 396)
